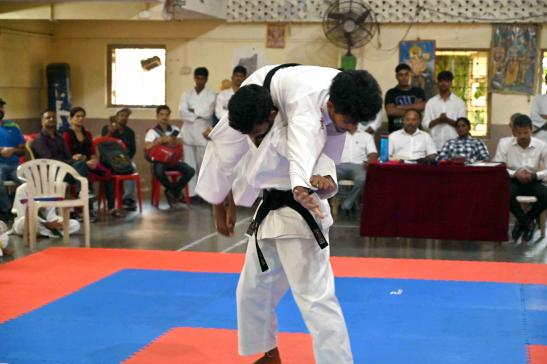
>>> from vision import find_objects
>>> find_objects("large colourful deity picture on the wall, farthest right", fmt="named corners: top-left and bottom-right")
top-left (490, 24), bottom-right (540, 95)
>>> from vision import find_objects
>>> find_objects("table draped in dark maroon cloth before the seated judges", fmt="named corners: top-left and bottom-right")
top-left (361, 162), bottom-right (509, 241)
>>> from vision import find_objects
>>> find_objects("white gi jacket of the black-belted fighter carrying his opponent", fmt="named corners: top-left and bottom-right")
top-left (232, 121), bottom-right (337, 239)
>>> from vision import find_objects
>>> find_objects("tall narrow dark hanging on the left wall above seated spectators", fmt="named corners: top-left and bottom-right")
top-left (46, 63), bottom-right (72, 131)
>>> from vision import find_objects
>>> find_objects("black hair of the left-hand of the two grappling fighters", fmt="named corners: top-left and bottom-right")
top-left (228, 85), bottom-right (274, 134)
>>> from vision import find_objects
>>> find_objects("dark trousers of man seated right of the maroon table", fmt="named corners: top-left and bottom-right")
top-left (509, 178), bottom-right (547, 226)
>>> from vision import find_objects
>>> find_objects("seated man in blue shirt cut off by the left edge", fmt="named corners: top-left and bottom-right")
top-left (0, 98), bottom-right (25, 222)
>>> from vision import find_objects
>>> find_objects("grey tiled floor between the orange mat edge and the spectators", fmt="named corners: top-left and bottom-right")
top-left (5, 199), bottom-right (547, 263)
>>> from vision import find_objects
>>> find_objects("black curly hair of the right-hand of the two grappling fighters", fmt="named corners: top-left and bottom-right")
top-left (329, 70), bottom-right (382, 123)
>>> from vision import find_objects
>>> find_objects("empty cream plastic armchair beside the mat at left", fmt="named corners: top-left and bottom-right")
top-left (17, 159), bottom-right (91, 251)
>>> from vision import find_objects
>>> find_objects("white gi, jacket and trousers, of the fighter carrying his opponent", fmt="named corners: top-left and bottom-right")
top-left (232, 123), bottom-right (353, 364)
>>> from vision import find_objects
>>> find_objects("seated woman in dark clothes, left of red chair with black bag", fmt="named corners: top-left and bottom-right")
top-left (63, 107), bottom-right (125, 217)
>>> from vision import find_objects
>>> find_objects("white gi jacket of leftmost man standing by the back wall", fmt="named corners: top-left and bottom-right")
top-left (179, 88), bottom-right (216, 146)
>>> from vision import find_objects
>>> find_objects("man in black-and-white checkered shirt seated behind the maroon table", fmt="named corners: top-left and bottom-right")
top-left (437, 117), bottom-right (490, 163)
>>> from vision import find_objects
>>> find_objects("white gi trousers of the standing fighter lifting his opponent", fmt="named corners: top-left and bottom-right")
top-left (237, 237), bottom-right (353, 364)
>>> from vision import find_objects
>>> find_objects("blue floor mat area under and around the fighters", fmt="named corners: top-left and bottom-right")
top-left (0, 269), bottom-right (547, 364)
